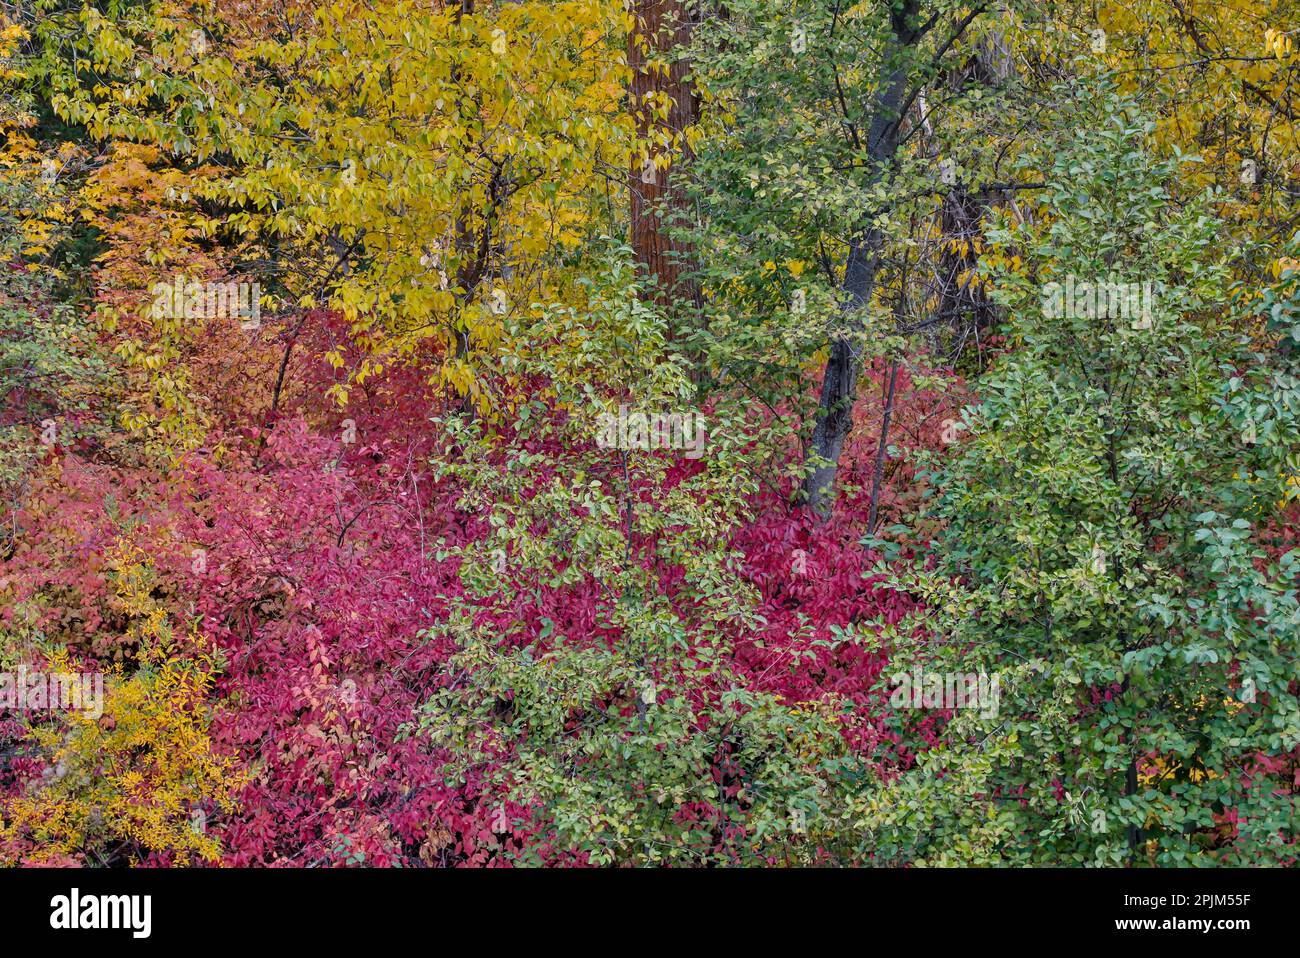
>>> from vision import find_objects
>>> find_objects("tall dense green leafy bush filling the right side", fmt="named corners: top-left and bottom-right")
top-left (863, 84), bottom-right (1300, 866)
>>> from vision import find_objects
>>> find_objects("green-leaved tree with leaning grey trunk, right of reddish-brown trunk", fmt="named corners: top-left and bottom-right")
top-left (692, 0), bottom-right (1029, 517)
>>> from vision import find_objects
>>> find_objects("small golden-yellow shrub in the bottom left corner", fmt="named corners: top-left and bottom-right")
top-left (0, 543), bottom-right (244, 864)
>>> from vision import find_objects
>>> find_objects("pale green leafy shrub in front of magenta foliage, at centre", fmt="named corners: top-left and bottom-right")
top-left (410, 250), bottom-right (848, 864)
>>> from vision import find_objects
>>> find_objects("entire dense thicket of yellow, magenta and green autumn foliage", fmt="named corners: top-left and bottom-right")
top-left (0, 0), bottom-right (1300, 866)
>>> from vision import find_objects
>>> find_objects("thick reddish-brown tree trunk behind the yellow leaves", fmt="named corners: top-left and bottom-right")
top-left (628, 0), bottom-right (699, 304)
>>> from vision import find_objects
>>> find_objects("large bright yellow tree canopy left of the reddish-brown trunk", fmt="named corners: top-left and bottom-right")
top-left (35, 0), bottom-right (634, 408)
